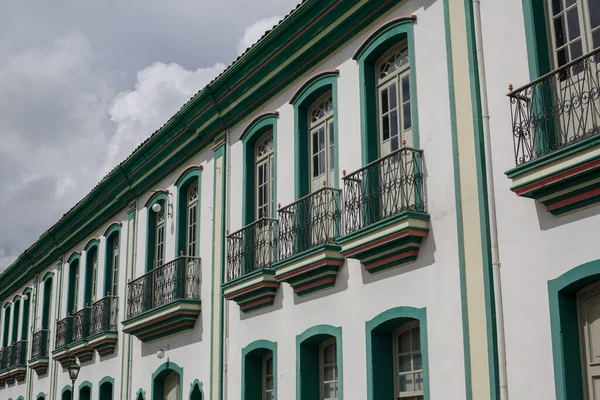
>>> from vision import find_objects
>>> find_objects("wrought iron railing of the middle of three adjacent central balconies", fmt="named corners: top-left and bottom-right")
top-left (277, 187), bottom-right (342, 261)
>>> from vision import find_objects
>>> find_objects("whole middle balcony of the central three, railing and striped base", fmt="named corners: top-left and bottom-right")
top-left (273, 187), bottom-right (344, 296)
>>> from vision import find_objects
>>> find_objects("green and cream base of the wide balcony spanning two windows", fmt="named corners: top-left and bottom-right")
top-left (123, 299), bottom-right (201, 343)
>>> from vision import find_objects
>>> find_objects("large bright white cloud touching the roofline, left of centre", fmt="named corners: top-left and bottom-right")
top-left (98, 62), bottom-right (225, 179)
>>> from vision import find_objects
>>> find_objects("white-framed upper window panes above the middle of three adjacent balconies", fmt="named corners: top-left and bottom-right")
top-left (308, 91), bottom-right (335, 192)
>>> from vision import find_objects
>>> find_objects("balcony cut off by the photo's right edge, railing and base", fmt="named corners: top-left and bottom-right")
top-left (506, 48), bottom-right (600, 215)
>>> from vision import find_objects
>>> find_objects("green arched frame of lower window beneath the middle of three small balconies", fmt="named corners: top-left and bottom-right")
top-left (296, 325), bottom-right (344, 400)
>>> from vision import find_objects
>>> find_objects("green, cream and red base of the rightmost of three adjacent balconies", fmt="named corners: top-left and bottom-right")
top-left (338, 211), bottom-right (429, 274)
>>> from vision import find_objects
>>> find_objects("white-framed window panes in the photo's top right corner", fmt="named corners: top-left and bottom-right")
top-left (547, 0), bottom-right (600, 68)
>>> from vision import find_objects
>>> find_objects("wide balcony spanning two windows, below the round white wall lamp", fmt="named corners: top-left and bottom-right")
top-left (123, 256), bottom-right (201, 342)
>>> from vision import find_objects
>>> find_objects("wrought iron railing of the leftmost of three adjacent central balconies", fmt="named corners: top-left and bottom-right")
top-left (227, 218), bottom-right (277, 281)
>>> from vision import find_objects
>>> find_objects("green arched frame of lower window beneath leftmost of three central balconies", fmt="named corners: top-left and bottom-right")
top-left (242, 340), bottom-right (277, 400)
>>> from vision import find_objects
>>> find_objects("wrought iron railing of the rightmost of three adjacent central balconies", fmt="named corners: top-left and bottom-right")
top-left (342, 147), bottom-right (425, 234)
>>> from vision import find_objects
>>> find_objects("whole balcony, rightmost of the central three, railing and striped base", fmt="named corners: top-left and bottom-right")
top-left (338, 147), bottom-right (429, 274)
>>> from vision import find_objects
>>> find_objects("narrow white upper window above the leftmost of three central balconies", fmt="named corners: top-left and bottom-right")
top-left (255, 130), bottom-right (275, 219)
